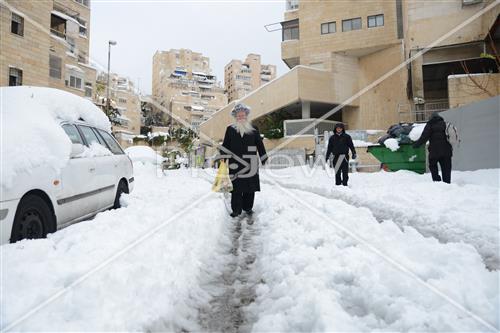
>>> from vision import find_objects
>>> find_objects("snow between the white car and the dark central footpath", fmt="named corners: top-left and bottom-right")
top-left (0, 163), bottom-right (230, 332)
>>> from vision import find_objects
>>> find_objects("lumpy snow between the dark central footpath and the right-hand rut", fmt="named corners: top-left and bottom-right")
top-left (247, 185), bottom-right (499, 332)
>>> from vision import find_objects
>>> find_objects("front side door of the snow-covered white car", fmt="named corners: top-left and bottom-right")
top-left (56, 124), bottom-right (98, 227)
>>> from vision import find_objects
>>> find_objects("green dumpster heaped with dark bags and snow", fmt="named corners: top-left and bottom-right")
top-left (368, 144), bottom-right (426, 174)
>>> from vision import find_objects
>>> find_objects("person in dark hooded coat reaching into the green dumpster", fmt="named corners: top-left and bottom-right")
top-left (413, 112), bottom-right (453, 184)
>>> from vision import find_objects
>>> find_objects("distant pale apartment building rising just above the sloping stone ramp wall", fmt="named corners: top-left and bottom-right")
top-left (224, 54), bottom-right (276, 102)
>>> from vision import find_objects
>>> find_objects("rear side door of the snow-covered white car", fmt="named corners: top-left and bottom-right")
top-left (77, 125), bottom-right (118, 210)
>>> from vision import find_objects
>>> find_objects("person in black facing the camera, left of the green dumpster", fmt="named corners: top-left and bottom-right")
top-left (326, 123), bottom-right (356, 186)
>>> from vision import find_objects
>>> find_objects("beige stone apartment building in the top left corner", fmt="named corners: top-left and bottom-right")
top-left (0, 0), bottom-right (96, 98)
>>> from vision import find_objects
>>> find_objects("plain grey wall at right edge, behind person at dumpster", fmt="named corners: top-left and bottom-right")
top-left (441, 96), bottom-right (500, 171)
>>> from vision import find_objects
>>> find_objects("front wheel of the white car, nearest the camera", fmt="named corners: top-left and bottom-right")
top-left (10, 194), bottom-right (54, 243)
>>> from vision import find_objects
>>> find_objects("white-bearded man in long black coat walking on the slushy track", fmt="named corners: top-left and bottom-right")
top-left (221, 103), bottom-right (267, 217)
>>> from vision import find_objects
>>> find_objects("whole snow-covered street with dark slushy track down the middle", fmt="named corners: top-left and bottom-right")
top-left (1, 163), bottom-right (499, 332)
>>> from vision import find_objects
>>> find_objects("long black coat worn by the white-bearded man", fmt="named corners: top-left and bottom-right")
top-left (221, 126), bottom-right (267, 192)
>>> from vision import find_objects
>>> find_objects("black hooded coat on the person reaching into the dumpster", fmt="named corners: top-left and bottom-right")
top-left (413, 115), bottom-right (453, 159)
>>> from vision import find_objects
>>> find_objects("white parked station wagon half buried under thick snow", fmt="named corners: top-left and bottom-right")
top-left (0, 121), bottom-right (134, 244)
